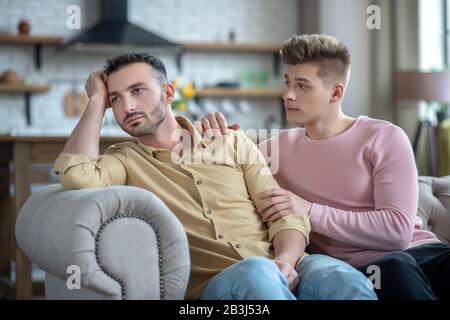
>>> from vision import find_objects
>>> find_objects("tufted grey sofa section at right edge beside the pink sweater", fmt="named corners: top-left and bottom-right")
top-left (417, 176), bottom-right (450, 243)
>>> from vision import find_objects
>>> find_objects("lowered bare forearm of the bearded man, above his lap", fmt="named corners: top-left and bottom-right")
top-left (272, 229), bottom-right (306, 268)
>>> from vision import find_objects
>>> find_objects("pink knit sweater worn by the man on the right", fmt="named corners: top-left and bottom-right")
top-left (260, 116), bottom-right (438, 266)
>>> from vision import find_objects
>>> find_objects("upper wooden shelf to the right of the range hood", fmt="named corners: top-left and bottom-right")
top-left (182, 42), bottom-right (281, 53)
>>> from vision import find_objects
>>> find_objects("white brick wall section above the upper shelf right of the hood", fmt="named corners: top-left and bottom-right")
top-left (129, 0), bottom-right (298, 42)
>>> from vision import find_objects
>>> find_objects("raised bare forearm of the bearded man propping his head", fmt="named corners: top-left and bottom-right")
top-left (63, 96), bottom-right (105, 160)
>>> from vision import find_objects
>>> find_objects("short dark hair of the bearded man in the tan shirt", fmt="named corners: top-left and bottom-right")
top-left (104, 53), bottom-right (167, 84)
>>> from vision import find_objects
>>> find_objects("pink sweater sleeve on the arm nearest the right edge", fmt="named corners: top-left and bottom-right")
top-left (310, 124), bottom-right (418, 250)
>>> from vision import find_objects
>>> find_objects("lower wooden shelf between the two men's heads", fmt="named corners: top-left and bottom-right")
top-left (196, 88), bottom-right (283, 98)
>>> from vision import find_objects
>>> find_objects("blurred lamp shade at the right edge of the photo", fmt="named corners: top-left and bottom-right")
top-left (396, 71), bottom-right (450, 102)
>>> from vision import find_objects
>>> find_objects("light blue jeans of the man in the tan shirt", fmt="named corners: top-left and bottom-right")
top-left (200, 254), bottom-right (377, 300)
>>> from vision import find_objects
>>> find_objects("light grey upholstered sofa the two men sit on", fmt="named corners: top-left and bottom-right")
top-left (16, 176), bottom-right (450, 299)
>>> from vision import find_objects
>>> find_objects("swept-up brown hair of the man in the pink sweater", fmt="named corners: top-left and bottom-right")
top-left (280, 34), bottom-right (351, 84)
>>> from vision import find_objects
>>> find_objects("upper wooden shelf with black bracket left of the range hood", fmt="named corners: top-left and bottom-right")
top-left (0, 33), bottom-right (62, 70)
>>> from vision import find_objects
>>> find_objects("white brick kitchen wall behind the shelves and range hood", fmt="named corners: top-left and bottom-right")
top-left (0, 0), bottom-right (298, 135)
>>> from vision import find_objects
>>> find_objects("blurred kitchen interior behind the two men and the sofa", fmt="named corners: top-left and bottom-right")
top-left (0, 0), bottom-right (450, 299)
